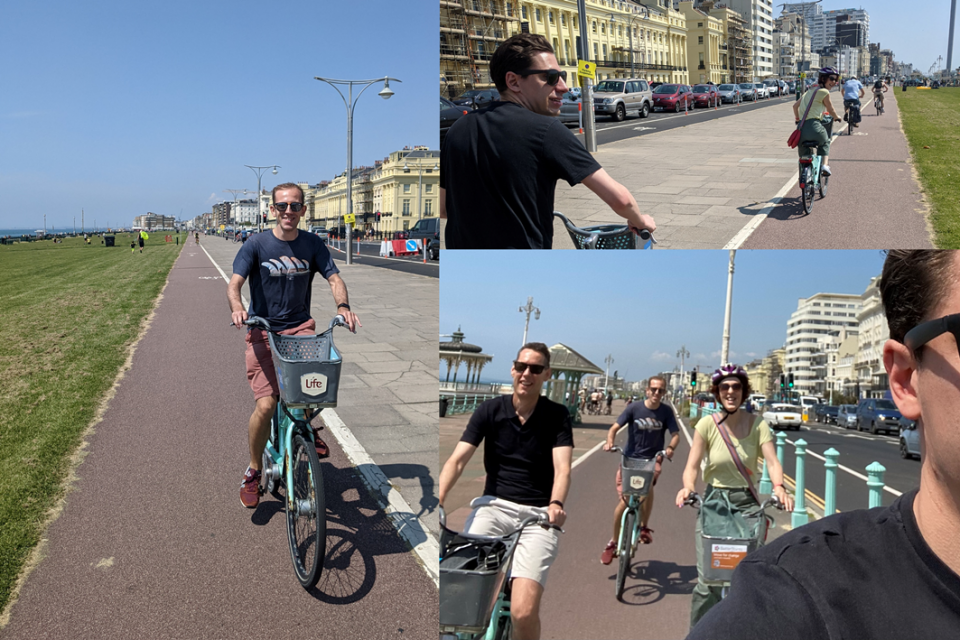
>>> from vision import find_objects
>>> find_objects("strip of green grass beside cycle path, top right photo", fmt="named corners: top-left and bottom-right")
top-left (896, 87), bottom-right (960, 249)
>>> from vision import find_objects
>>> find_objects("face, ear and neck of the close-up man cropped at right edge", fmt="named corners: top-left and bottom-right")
top-left (913, 254), bottom-right (960, 482)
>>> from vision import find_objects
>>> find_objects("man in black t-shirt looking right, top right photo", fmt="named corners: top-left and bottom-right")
top-left (440, 33), bottom-right (656, 249)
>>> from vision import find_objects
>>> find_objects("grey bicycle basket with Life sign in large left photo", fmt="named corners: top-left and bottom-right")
top-left (267, 329), bottom-right (343, 407)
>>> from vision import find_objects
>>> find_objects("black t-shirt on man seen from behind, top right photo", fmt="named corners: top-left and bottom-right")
top-left (440, 102), bottom-right (600, 249)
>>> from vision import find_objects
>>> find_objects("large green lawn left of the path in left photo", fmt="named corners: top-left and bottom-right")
top-left (0, 233), bottom-right (183, 611)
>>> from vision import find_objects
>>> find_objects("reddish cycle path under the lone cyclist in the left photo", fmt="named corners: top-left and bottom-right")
top-left (0, 245), bottom-right (438, 640)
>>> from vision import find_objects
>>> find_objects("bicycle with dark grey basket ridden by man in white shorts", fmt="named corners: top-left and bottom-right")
top-left (440, 507), bottom-right (563, 640)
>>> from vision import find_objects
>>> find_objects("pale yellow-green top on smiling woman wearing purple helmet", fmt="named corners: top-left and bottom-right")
top-left (694, 412), bottom-right (772, 489)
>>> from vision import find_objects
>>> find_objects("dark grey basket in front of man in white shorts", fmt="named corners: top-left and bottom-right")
top-left (440, 536), bottom-right (510, 633)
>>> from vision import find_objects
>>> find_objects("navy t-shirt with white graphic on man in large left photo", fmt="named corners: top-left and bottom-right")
top-left (233, 231), bottom-right (340, 331)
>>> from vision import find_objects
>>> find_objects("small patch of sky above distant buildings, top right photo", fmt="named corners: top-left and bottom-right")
top-left (792, 0), bottom-right (960, 73)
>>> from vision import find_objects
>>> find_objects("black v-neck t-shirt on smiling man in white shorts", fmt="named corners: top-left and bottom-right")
top-left (460, 396), bottom-right (573, 507)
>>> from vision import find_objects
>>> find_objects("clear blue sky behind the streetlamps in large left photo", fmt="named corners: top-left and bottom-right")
top-left (0, 0), bottom-right (439, 229)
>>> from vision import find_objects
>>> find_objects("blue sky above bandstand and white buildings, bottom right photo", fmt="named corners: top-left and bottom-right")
top-left (440, 250), bottom-right (883, 380)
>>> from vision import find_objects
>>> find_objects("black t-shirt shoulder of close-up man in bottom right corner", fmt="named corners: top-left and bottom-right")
top-left (687, 490), bottom-right (960, 640)
